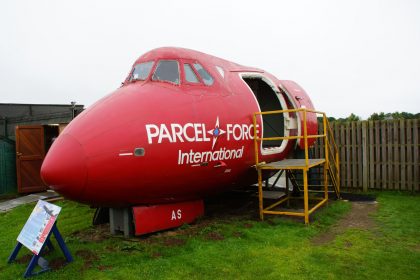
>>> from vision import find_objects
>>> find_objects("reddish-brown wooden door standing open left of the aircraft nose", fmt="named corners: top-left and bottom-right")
top-left (16, 125), bottom-right (47, 193)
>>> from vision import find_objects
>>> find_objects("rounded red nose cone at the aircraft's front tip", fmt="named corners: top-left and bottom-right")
top-left (41, 134), bottom-right (87, 200)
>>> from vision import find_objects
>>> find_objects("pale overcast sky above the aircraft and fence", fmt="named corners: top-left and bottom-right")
top-left (0, 0), bottom-right (420, 118)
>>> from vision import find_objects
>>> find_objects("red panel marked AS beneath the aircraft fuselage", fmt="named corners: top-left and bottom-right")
top-left (133, 200), bottom-right (204, 235)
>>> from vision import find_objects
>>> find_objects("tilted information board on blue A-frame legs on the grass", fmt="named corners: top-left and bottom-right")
top-left (8, 200), bottom-right (73, 277)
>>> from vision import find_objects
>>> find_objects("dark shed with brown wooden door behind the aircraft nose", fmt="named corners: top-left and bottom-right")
top-left (0, 103), bottom-right (84, 195)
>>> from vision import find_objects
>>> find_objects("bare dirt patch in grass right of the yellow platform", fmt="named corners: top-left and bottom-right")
top-left (312, 202), bottom-right (377, 247)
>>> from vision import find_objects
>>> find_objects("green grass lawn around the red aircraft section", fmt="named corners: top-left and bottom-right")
top-left (0, 192), bottom-right (420, 280)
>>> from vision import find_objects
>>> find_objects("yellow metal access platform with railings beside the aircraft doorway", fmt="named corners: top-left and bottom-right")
top-left (253, 108), bottom-right (340, 224)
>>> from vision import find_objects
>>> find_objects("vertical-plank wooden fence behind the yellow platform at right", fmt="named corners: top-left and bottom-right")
top-left (313, 120), bottom-right (420, 192)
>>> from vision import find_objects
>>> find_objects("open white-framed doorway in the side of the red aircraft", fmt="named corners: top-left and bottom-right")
top-left (242, 74), bottom-right (289, 155)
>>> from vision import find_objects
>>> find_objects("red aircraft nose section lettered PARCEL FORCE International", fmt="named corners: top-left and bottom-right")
top-left (41, 48), bottom-right (317, 207)
